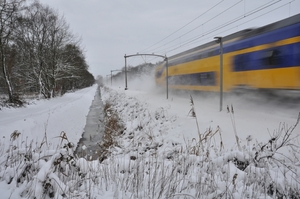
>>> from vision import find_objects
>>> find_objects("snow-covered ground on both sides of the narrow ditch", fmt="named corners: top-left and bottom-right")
top-left (0, 77), bottom-right (300, 199)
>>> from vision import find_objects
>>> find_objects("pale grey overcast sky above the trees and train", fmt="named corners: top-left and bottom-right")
top-left (40, 0), bottom-right (300, 77)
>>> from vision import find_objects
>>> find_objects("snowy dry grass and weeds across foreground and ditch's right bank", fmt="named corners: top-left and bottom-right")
top-left (0, 88), bottom-right (300, 199)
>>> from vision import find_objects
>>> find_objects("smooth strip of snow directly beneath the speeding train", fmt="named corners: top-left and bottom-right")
top-left (108, 74), bottom-right (300, 151)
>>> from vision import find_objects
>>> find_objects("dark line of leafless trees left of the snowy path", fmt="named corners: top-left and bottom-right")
top-left (0, 0), bottom-right (95, 103)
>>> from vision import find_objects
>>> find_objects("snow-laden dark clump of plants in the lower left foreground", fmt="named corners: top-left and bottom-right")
top-left (0, 131), bottom-right (93, 198)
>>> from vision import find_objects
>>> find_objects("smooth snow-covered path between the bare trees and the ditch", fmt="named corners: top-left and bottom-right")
top-left (0, 85), bottom-right (97, 145)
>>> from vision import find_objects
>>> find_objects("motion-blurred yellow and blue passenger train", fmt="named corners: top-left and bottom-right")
top-left (155, 14), bottom-right (300, 91)
